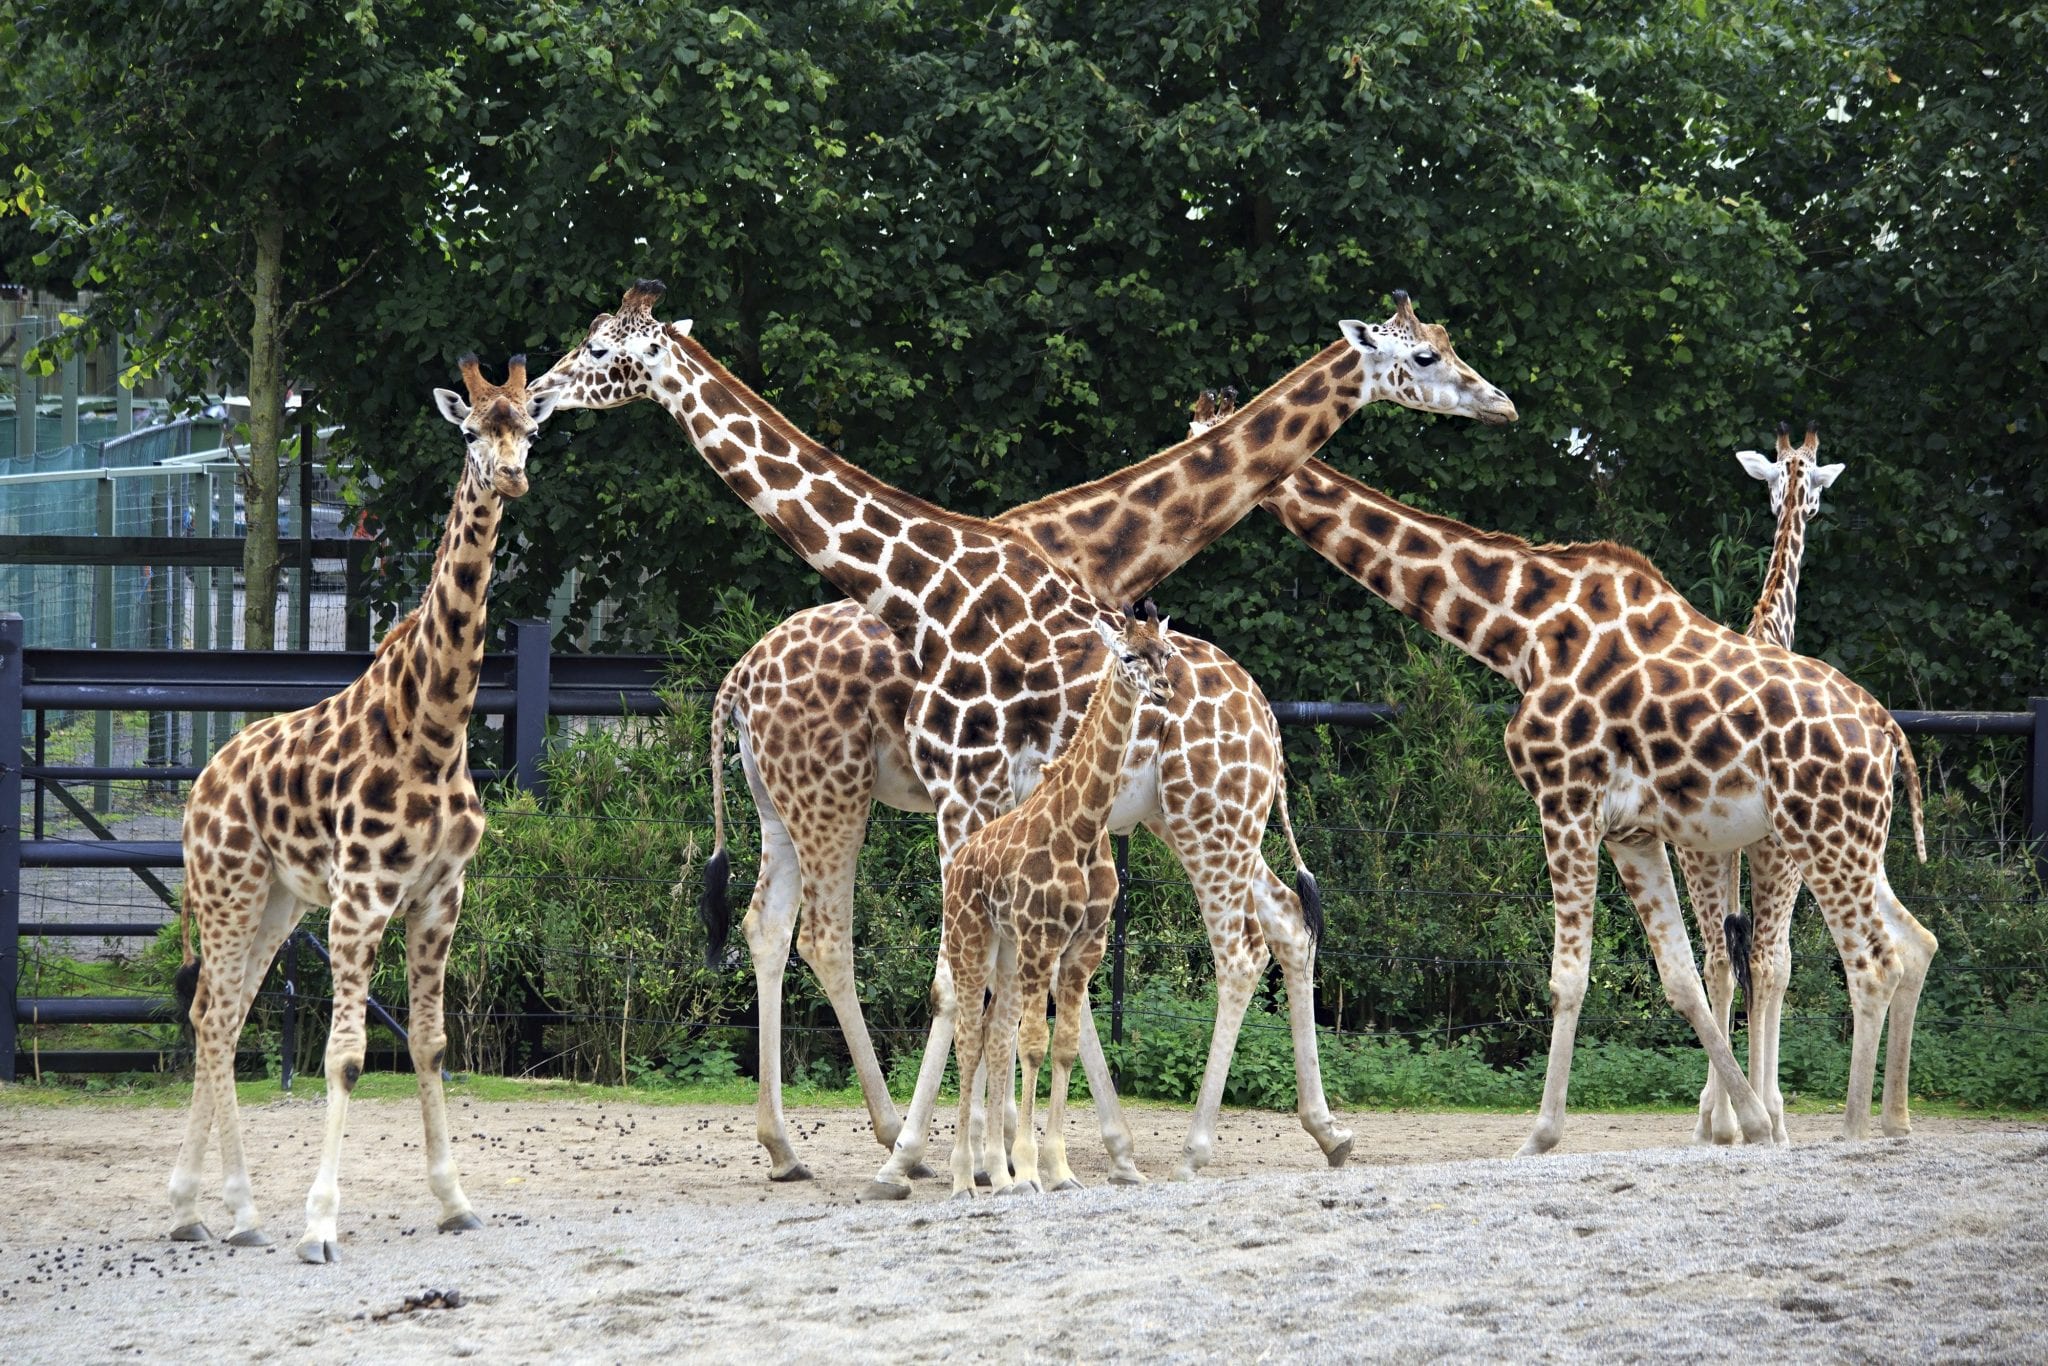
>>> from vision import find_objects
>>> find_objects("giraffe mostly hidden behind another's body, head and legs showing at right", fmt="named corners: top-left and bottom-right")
top-left (1677, 424), bottom-right (1843, 1143)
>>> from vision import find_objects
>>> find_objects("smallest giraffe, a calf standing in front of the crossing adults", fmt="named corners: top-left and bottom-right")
top-left (940, 604), bottom-right (1174, 1198)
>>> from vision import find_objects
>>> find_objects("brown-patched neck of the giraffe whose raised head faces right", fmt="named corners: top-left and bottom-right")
top-left (997, 340), bottom-right (1384, 602)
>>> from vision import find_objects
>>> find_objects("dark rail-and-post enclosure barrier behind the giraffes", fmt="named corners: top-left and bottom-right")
top-left (0, 614), bottom-right (2048, 1081)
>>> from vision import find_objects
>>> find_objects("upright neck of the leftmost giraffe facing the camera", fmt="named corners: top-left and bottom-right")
top-left (379, 473), bottom-right (504, 772)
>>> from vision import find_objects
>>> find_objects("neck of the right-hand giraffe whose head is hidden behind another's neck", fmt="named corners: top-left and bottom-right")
top-left (1266, 461), bottom-right (1704, 692)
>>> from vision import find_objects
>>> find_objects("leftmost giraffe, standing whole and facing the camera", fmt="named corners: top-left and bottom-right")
top-left (170, 356), bottom-right (555, 1264)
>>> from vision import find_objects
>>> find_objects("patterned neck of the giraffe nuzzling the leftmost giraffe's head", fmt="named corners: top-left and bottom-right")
top-left (655, 332), bottom-right (1044, 657)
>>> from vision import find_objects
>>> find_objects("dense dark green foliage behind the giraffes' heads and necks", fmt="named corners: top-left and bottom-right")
top-left (12, 0), bottom-right (2048, 707)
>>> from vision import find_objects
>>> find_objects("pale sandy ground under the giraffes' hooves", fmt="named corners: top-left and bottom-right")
top-left (0, 1092), bottom-right (2048, 1362)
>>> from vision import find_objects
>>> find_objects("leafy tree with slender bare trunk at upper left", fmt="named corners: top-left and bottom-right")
top-left (0, 0), bottom-right (463, 649)
